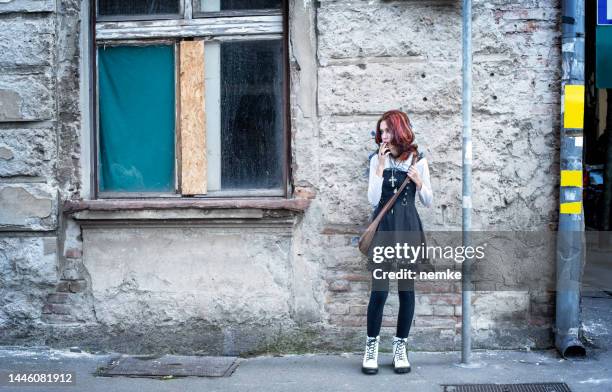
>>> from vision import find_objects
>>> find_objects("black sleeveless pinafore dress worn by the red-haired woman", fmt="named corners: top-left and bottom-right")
top-left (368, 161), bottom-right (427, 278)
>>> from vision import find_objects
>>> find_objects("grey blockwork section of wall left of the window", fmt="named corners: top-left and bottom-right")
top-left (0, 0), bottom-right (80, 343)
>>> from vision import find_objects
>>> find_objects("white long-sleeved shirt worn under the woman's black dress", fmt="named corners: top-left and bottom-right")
top-left (368, 153), bottom-right (433, 207)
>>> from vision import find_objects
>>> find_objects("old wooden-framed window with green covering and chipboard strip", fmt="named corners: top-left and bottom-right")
top-left (92, 0), bottom-right (288, 198)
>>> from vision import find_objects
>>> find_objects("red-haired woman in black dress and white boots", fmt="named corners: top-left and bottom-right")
top-left (362, 110), bottom-right (433, 374)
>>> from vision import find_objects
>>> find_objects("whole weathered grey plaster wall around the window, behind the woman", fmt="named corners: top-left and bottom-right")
top-left (0, 0), bottom-right (560, 354)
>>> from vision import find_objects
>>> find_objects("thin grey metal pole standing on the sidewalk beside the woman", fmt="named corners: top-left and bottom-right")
top-left (461, 0), bottom-right (472, 364)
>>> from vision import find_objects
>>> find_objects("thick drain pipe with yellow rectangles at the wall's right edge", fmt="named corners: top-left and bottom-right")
top-left (554, 0), bottom-right (586, 357)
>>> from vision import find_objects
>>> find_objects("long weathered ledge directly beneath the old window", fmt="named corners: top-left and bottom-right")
top-left (62, 198), bottom-right (310, 224)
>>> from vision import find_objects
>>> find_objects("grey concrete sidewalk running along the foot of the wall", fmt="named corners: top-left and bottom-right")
top-left (0, 297), bottom-right (612, 392)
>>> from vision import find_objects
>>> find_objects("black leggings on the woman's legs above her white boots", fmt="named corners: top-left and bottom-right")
top-left (368, 280), bottom-right (414, 338)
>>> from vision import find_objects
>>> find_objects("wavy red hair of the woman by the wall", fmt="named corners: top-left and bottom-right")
top-left (376, 110), bottom-right (419, 163)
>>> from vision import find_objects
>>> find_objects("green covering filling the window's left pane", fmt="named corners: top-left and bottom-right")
top-left (98, 45), bottom-right (175, 192)
